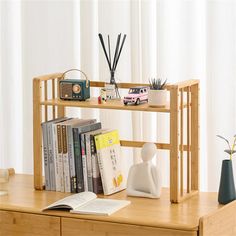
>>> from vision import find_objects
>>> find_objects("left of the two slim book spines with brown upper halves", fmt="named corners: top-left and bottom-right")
top-left (56, 124), bottom-right (65, 192)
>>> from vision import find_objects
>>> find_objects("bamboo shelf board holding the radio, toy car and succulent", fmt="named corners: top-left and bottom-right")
top-left (41, 98), bottom-right (170, 113)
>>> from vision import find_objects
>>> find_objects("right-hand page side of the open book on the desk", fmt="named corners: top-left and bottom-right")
top-left (70, 198), bottom-right (130, 215)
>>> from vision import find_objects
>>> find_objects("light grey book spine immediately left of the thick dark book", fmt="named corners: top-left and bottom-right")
top-left (67, 125), bottom-right (76, 193)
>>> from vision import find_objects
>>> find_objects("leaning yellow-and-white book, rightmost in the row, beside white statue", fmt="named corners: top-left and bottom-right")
top-left (95, 130), bottom-right (126, 195)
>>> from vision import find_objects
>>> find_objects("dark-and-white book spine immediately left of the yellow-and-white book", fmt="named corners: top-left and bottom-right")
top-left (90, 135), bottom-right (103, 194)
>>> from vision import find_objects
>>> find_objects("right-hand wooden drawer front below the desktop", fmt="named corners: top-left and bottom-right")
top-left (62, 218), bottom-right (197, 236)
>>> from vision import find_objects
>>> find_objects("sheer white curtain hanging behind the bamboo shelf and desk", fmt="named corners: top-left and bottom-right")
top-left (0, 0), bottom-right (236, 191)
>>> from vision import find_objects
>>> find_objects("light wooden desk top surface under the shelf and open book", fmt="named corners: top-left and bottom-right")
top-left (0, 174), bottom-right (225, 230)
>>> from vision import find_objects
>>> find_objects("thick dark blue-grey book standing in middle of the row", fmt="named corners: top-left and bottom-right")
top-left (72, 122), bottom-right (102, 192)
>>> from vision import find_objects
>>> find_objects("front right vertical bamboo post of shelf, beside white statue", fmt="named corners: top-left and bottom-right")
top-left (170, 86), bottom-right (179, 203)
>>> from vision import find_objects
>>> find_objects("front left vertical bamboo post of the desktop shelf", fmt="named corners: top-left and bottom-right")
top-left (33, 79), bottom-right (43, 190)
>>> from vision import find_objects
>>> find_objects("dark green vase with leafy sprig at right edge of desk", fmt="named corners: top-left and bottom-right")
top-left (217, 135), bottom-right (236, 204)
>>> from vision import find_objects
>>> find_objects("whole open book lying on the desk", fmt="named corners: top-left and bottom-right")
top-left (43, 192), bottom-right (130, 215)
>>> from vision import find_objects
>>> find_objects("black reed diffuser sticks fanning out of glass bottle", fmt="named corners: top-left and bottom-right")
top-left (98, 34), bottom-right (126, 97)
